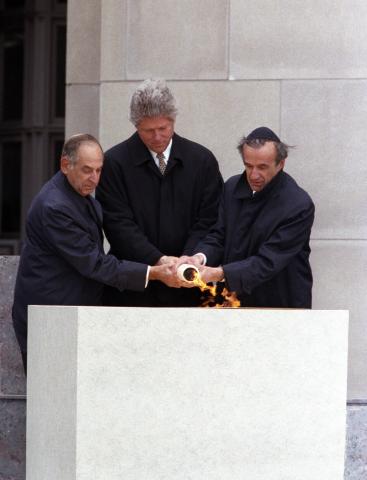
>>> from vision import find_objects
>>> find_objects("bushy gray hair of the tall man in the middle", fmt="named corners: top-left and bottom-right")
top-left (130, 79), bottom-right (177, 127)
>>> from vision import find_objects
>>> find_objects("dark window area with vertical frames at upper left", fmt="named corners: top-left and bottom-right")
top-left (0, 0), bottom-right (66, 255)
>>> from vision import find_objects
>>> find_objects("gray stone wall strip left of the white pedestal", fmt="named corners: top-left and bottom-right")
top-left (0, 257), bottom-right (26, 480)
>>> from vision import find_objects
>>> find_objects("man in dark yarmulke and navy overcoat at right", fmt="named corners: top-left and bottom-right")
top-left (180, 127), bottom-right (315, 308)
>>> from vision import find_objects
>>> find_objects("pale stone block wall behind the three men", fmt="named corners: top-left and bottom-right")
top-left (66, 0), bottom-right (367, 401)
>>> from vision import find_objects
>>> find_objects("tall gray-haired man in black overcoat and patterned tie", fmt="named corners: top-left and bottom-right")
top-left (97, 80), bottom-right (223, 306)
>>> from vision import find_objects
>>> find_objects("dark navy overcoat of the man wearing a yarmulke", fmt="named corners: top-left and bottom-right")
top-left (195, 171), bottom-right (315, 308)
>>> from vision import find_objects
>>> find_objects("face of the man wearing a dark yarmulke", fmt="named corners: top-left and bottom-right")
top-left (242, 142), bottom-right (285, 192)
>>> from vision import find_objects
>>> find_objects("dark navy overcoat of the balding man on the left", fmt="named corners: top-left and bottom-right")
top-left (13, 172), bottom-right (147, 352)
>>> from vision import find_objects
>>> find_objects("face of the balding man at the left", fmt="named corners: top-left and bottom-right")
top-left (61, 143), bottom-right (103, 197)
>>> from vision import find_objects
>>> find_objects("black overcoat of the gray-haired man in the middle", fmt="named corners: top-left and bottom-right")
top-left (97, 129), bottom-right (223, 306)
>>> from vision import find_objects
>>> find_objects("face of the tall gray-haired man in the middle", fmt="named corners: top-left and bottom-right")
top-left (136, 117), bottom-right (175, 153)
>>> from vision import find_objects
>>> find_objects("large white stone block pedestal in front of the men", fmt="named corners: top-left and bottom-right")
top-left (27, 307), bottom-right (348, 480)
